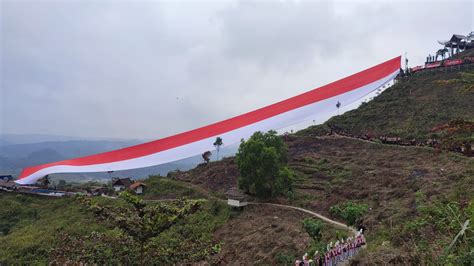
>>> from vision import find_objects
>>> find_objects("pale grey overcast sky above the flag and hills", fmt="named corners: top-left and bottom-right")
top-left (0, 0), bottom-right (474, 139)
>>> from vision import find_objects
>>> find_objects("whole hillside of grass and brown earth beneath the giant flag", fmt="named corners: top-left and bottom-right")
top-left (0, 56), bottom-right (474, 265)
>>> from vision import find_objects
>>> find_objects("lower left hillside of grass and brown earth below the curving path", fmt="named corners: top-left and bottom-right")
top-left (0, 176), bottom-right (347, 265)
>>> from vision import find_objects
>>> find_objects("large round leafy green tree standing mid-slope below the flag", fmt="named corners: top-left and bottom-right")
top-left (236, 131), bottom-right (292, 198)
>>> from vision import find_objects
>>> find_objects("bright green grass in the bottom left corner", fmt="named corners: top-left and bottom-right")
top-left (0, 193), bottom-right (105, 264)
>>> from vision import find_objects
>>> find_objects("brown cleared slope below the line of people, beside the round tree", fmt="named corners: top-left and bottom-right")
top-left (170, 136), bottom-right (474, 263)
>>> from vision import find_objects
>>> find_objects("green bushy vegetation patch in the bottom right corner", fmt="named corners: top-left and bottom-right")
top-left (391, 192), bottom-right (474, 265)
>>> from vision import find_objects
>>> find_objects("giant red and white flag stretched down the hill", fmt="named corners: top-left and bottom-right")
top-left (16, 57), bottom-right (400, 184)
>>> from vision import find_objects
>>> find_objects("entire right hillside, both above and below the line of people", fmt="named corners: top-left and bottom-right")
top-left (168, 63), bottom-right (474, 264)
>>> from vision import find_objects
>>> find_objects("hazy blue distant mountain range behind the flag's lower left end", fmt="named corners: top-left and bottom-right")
top-left (0, 134), bottom-right (237, 182)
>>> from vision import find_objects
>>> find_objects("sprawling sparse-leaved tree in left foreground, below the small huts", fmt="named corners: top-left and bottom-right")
top-left (52, 192), bottom-right (200, 265)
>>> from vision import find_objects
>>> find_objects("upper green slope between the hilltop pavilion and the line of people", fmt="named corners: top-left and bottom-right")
top-left (298, 66), bottom-right (474, 140)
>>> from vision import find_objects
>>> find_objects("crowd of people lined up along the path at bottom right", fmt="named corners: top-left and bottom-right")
top-left (295, 229), bottom-right (365, 266)
